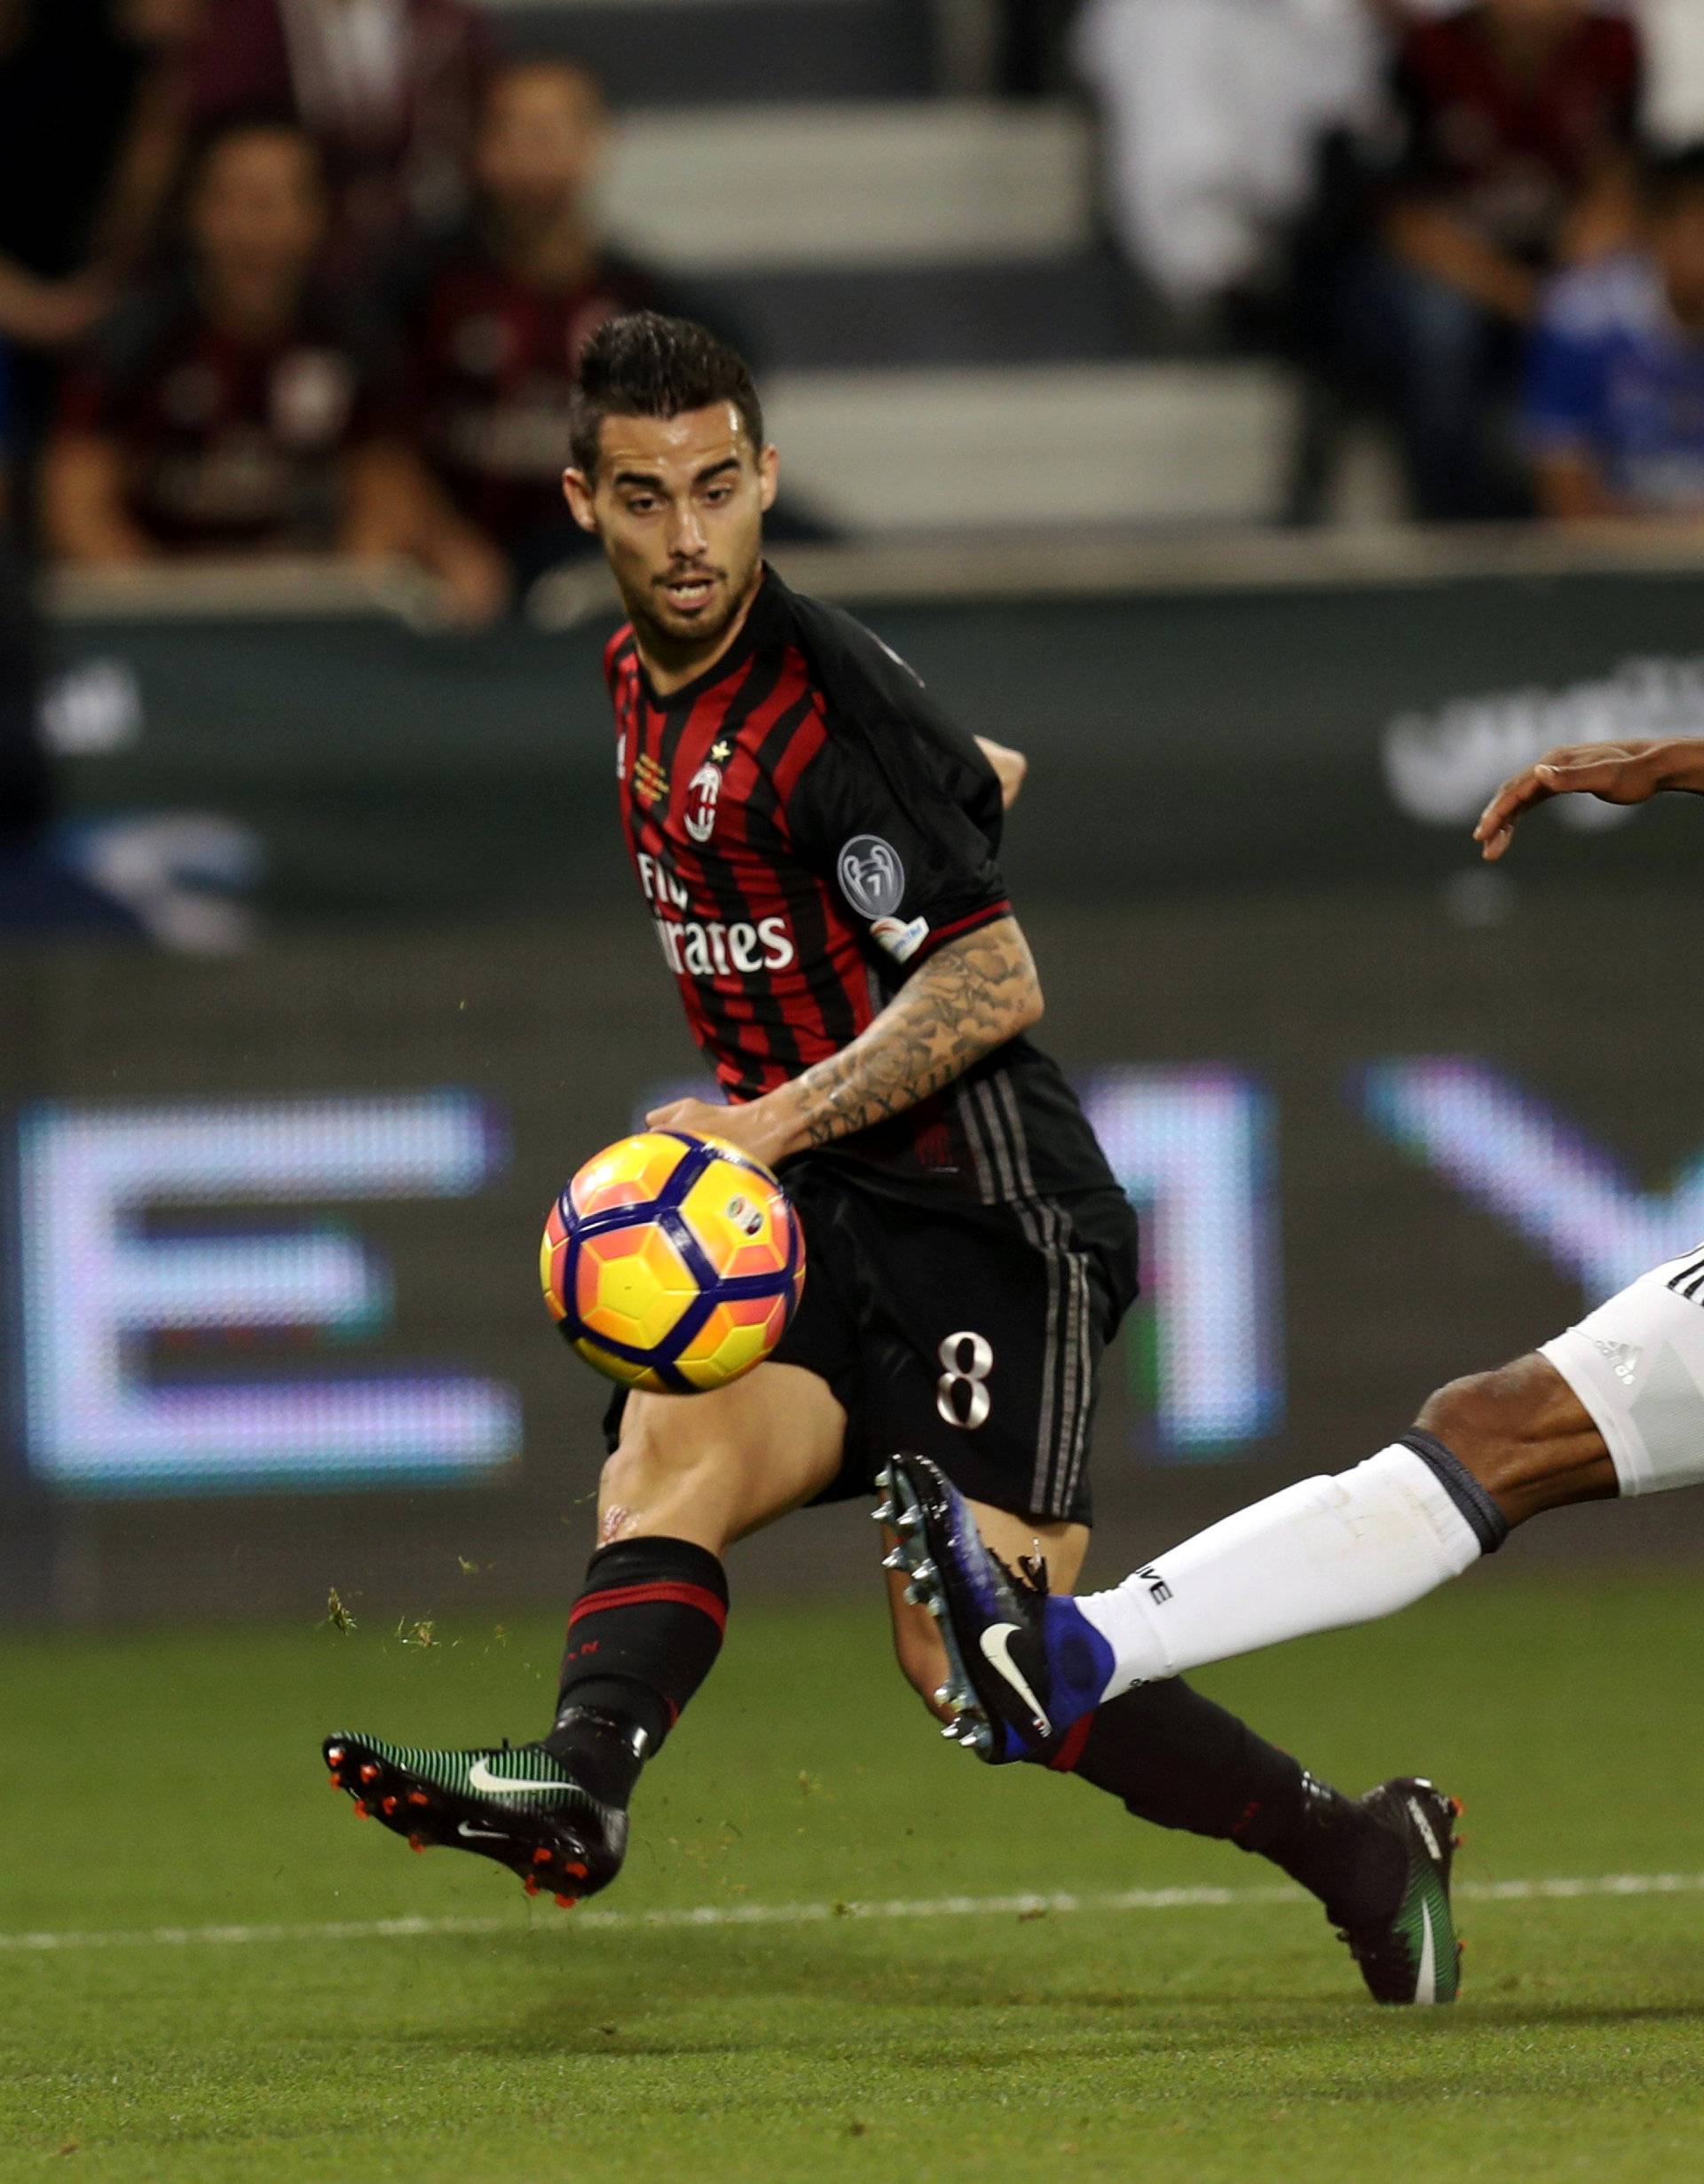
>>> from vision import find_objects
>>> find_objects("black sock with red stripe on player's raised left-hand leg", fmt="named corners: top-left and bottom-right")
top-left (544, 1540), bottom-right (728, 1804)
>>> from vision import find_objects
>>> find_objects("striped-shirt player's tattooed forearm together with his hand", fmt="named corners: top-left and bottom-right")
top-left (647, 918), bottom-right (1042, 1164)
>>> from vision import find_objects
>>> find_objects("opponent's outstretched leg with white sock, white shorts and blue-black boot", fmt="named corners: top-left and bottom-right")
top-left (895, 1250), bottom-right (1704, 1957)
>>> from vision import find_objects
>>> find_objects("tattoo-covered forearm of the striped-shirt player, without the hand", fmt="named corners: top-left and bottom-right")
top-left (791, 918), bottom-right (1042, 1145)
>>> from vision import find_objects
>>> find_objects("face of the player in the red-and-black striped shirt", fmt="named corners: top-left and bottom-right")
top-left (564, 402), bottom-right (776, 658)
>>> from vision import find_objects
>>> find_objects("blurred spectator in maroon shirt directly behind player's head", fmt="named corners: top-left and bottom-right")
top-left (398, 61), bottom-right (746, 583)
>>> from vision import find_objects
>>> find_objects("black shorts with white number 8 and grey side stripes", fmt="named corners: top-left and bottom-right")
top-left (607, 1160), bottom-right (1136, 1525)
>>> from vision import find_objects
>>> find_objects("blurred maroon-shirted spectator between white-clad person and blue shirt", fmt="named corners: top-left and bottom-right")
top-left (1357, 0), bottom-right (1643, 520)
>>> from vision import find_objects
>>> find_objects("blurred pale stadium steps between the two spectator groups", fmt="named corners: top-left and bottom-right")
top-left (478, 0), bottom-right (1291, 532)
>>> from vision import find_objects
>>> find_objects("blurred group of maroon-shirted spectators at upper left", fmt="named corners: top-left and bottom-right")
top-left (0, 0), bottom-right (690, 622)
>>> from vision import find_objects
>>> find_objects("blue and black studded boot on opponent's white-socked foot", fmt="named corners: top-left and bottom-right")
top-left (876, 1455), bottom-right (1114, 1767)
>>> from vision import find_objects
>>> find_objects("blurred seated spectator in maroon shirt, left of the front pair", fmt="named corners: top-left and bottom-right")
top-left (43, 122), bottom-right (505, 620)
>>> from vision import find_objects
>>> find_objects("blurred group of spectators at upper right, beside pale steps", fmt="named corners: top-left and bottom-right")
top-left (1073, 0), bottom-right (1704, 522)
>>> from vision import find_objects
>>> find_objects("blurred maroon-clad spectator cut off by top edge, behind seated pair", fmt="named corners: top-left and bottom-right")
top-left (190, 0), bottom-right (489, 271)
